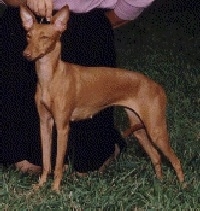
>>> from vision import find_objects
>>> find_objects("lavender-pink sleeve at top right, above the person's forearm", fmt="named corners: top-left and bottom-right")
top-left (114, 0), bottom-right (154, 20)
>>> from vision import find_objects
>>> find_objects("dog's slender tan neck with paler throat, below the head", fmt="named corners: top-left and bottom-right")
top-left (35, 41), bottom-right (61, 86)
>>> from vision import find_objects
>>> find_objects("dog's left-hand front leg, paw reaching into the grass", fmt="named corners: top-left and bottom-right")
top-left (34, 102), bottom-right (54, 190)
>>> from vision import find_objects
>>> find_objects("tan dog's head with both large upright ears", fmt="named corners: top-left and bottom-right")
top-left (20, 5), bottom-right (69, 61)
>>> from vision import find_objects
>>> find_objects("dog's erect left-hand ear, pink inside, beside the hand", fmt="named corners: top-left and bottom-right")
top-left (20, 5), bottom-right (35, 30)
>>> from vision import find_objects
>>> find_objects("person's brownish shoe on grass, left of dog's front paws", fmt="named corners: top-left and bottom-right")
top-left (15, 160), bottom-right (41, 173)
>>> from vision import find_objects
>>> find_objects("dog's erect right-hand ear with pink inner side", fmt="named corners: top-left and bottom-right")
top-left (51, 5), bottom-right (69, 32)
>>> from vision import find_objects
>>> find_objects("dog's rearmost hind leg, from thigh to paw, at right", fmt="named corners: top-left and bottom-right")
top-left (140, 92), bottom-right (184, 182)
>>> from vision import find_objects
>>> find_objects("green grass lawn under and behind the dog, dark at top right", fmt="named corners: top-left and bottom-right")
top-left (0, 2), bottom-right (200, 210)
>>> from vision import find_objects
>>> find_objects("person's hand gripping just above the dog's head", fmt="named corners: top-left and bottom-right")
top-left (26, 0), bottom-right (53, 21)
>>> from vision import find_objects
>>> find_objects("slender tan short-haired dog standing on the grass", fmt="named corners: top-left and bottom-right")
top-left (20, 6), bottom-right (184, 191)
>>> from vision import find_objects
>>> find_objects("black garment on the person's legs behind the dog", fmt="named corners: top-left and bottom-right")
top-left (2, 8), bottom-right (123, 172)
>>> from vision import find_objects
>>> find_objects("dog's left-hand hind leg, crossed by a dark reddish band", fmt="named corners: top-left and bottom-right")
top-left (126, 109), bottom-right (162, 179)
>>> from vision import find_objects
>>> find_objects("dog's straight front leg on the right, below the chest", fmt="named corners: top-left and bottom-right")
top-left (52, 120), bottom-right (69, 192)
